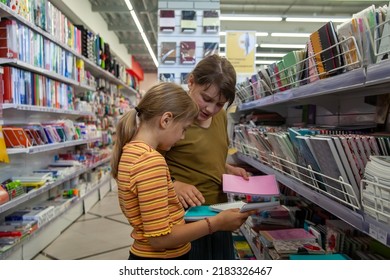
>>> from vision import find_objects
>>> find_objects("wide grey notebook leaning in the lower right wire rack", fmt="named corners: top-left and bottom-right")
top-left (310, 136), bottom-right (359, 203)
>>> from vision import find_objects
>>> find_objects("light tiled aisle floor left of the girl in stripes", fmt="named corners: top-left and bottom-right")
top-left (34, 186), bottom-right (132, 260)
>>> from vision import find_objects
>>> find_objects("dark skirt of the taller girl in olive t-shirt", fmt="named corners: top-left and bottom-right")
top-left (190, 231), bottom-right (235, 260)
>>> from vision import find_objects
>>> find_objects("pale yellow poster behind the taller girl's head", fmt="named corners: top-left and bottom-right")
top-left (226, 31), bottom-right (256, 74)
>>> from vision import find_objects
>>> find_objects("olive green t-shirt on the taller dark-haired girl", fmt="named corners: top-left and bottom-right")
top-left (165, 110), bottom-right (229, 204)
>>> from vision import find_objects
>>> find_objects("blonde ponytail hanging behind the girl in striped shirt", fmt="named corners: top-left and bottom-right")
top-left (111, 109), bottom-right (137, 179)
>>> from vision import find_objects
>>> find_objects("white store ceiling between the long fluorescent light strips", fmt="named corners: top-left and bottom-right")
top-left (89, 0), bottom-right (389, 73)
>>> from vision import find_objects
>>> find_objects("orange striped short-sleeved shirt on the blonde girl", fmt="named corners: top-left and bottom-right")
top-left (117, 141), bottom-right (191, 259)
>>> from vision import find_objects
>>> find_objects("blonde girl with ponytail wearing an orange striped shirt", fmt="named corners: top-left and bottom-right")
top-left (111, 83), bottom-right (251, 259)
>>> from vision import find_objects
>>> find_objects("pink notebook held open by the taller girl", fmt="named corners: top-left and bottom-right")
top-left (222, 174), bottom-right (280, 196)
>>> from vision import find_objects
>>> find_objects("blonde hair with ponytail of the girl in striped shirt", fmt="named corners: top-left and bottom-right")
top-left (111, 83), bottom-right (199, 179)
